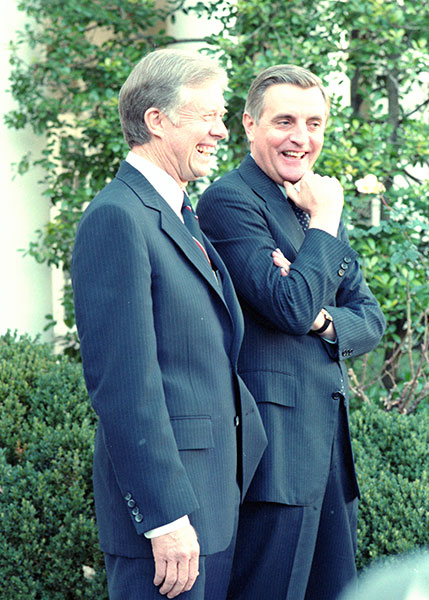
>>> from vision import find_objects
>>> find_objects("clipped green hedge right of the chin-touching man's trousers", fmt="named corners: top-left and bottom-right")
top-left (351, 404), bottom-right (429, 568)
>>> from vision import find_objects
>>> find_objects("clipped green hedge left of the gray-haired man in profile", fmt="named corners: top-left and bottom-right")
top-left (0, 333), bottom-right (107, 600)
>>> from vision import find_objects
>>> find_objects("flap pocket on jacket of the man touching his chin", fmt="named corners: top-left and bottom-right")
top-left (240, 370), bottom-right (297, 406)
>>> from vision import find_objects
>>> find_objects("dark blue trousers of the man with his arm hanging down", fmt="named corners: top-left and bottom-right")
top-left (104, 508), bottom-right (238, 600)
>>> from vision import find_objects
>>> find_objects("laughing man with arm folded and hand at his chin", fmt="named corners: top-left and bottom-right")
top-left (197, 65), bottom-right (385, 600)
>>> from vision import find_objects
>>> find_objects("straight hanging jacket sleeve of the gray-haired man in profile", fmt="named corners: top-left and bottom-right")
top-left (72, 206), bottom-right (198, 534)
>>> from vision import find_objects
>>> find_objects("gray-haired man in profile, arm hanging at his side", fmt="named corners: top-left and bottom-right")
top-left (72, 49), bottom-right (266, 600)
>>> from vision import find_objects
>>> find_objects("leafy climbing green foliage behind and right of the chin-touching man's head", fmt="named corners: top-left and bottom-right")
top-left (196, 0), bottom-right (429, 406)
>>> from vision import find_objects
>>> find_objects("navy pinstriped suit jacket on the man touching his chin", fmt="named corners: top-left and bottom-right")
top-left (197, 155), bottom-right (385, 505)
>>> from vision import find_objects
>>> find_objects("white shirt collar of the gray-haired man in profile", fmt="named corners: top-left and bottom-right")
top-left (125, 150), bottom-right (183, 221)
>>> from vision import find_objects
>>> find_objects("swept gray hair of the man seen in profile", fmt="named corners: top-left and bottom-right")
top-left (119, 48), bottom-right (228, 148)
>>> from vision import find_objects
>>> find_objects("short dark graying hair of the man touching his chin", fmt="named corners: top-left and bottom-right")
top-left (244, 65), bottom-right (331, 123)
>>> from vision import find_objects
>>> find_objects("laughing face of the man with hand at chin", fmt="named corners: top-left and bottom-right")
top-left (243, 83), bottom-right (328, 184)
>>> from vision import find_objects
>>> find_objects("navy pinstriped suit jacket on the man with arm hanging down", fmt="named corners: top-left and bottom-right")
top-left (72, 162), bottom-right (266, 557)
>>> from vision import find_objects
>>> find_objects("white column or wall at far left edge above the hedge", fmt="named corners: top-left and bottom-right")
top-left (0, 0), bottom-right (52, 341)
